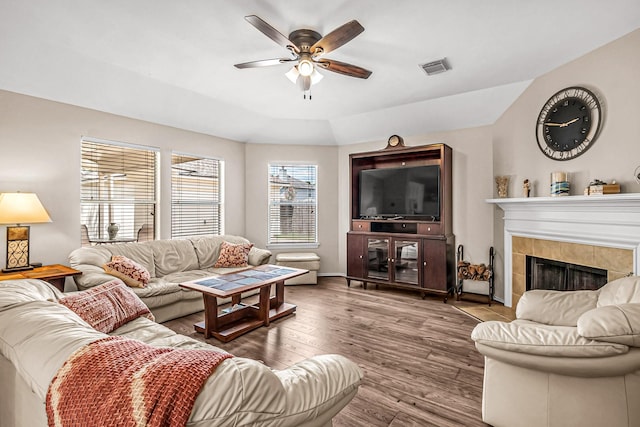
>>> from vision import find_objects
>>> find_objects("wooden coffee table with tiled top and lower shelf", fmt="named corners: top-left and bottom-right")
top-left (180, 264), bottom-right (309, 342)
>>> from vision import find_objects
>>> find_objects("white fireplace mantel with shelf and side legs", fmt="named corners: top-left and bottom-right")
top-left (486, 193), bottom-right (640, 307)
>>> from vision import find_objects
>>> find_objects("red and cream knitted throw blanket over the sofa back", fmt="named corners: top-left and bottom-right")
top-left (47, 337), bottom-right (233, 427)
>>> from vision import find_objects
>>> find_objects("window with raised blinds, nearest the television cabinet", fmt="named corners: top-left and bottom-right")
top-left (268, 163), bottom-right (318, 245)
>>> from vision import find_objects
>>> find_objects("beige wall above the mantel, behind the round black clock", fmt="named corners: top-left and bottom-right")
top-left (493, 30), bottom-right (640, 295)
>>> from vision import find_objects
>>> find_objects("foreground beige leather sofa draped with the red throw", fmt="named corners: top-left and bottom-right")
top-left (0, 279), bottom-right (362, 427)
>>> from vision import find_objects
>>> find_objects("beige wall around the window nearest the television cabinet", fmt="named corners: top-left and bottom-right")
top-left (245, 144), bottom-right (345, 274)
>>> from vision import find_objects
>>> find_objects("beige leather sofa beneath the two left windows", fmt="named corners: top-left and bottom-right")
top-left (69, 235), bottom-right (271, 323)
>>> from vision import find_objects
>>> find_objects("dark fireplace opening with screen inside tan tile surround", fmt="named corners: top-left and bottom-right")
top-left (527, 256), bottom-right (607, 291)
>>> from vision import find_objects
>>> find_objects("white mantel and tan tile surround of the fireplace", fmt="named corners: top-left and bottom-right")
top-left (486, 193), bottom-right (640, 307)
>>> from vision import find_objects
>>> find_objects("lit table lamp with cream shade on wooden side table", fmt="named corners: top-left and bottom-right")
top-left (0, 193), bottom-right (51, 272)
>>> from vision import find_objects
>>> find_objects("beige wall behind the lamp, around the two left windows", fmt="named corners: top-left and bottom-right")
top-left (0, 91), bottom-right (252, 268)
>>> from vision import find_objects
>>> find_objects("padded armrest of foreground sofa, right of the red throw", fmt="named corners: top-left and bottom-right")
top-left (189, 355), bottom-right (362, 426)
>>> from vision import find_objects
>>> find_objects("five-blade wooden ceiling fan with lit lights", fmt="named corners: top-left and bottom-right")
top-left (235, 15), bottom-right (371, 99)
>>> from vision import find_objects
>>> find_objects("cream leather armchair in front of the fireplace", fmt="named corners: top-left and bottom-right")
top-left (471, 276), bottom-right (640, 427)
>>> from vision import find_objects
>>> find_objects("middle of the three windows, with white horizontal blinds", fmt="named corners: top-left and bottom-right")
top-left (171, 153), bottom-right (224, 238)
